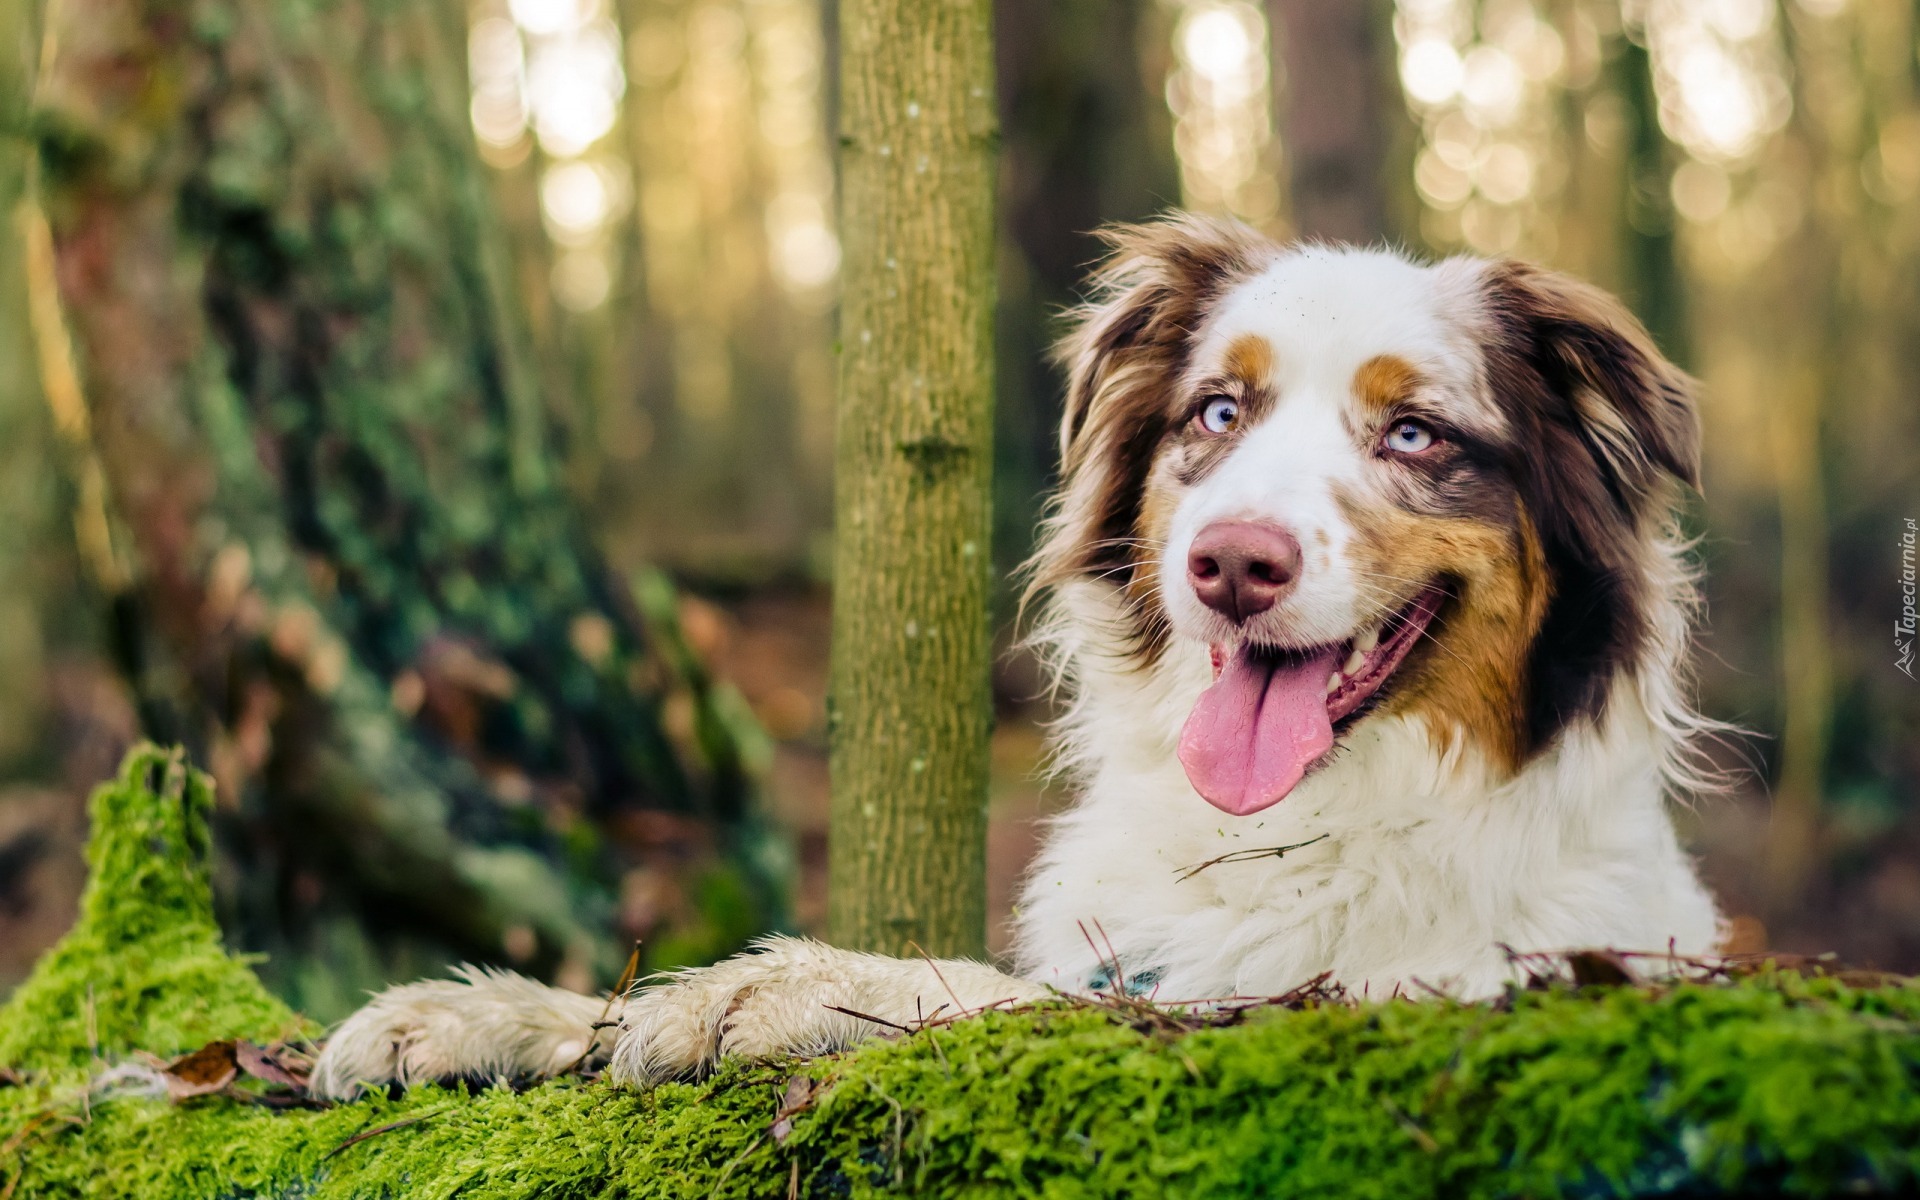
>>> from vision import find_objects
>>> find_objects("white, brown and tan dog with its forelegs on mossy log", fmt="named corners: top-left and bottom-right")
top-left (313, 215), bottom-right (1722, 1096)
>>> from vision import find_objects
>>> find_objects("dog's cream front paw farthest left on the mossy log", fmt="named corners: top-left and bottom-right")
top-left (309, 966), bottom-right (612, 1100)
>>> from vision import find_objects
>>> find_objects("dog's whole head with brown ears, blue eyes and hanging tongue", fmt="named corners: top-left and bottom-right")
top-left (1035, 217), bottom-right (1697, 814)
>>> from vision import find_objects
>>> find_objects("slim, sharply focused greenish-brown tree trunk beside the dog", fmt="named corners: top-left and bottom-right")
top-left (828, 0), bottom-right (998, 954)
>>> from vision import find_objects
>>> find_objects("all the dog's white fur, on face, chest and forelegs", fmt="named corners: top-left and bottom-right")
top-left (315, 236), bottom-right (1716, 1096)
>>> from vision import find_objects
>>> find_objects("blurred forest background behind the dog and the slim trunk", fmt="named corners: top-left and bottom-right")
top-left (0, 0), bottom-right (1920, 1020)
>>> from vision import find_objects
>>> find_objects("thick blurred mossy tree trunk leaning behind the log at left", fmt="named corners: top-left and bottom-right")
top-left (35, 0), bottom-right (770, 1012)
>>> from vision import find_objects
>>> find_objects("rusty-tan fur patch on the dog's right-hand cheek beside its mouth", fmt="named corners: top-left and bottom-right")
top-left (1336, 483), bottom-right (1551, 772)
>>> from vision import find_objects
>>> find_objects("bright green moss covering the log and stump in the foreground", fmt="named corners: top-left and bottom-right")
top-left (0, 751), bottom-right (1920, 1200)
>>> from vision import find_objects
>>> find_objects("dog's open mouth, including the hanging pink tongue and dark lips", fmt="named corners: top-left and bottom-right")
top-left (1181, 584), bottom-right (1446, 816)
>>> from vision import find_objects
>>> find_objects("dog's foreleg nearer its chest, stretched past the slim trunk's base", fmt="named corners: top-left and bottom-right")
top-left (609, 937), bottom-right (1048, 1087)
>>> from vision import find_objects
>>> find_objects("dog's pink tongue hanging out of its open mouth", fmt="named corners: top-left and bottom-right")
top-left (1181, 647), bottom-right (1340, 816)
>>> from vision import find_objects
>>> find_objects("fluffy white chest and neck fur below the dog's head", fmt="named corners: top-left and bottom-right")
top-left (1016, 572), bottom-right (1716, 1000)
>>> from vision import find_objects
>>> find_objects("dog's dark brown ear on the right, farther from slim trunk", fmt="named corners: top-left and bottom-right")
top-left (1482, 261), bottom-right (1699, 515)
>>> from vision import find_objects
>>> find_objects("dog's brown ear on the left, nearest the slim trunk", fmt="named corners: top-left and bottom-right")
top-left (1054, 213), bottom-right (1275, 476)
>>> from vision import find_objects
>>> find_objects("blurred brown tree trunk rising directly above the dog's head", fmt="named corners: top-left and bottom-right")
top-left (1267, 0), bottom-right (1400, 244)
